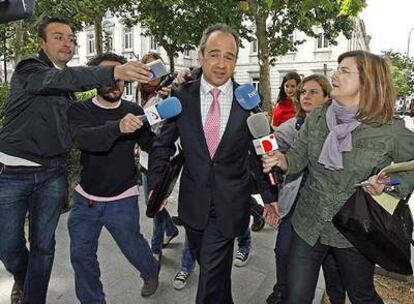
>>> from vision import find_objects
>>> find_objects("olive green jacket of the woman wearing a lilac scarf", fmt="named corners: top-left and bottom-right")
top-left (286, 105), bottom-right (414, 248)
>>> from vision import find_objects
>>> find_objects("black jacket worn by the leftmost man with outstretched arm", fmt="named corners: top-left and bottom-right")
top-left (0, 51), bottom-right (114, 166)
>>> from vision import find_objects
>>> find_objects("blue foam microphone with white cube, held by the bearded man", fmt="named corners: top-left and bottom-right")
top-left (138, 97), bottom-right (182, 126)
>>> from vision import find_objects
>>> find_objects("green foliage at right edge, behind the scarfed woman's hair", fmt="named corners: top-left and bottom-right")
top-left (384, 50), bottom-right (414, 96)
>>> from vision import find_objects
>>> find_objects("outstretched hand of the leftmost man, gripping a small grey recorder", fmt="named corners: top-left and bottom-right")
top-left (114, 60), bottom-right (151, 83)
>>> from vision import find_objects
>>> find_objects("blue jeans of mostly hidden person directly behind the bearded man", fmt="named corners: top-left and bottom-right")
top-left (142, 173), bottom-right (178, 253)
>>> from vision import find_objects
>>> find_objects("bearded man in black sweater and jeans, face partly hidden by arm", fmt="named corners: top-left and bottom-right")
top-left (68, 53), bottom-right (159, 303)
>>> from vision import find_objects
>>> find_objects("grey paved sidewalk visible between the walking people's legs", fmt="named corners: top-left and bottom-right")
top-left (0, 190), bottom-right (323, 304)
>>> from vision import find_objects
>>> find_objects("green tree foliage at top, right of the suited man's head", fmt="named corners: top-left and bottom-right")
top-left (247, 0), bottom-right (365, 63)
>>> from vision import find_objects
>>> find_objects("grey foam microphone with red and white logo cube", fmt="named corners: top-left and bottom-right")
top-left (247, 113), bottom-right (283, 186)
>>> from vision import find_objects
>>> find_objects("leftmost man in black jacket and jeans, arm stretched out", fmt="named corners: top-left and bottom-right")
top-left (0, 18), bottom-right (154, 304)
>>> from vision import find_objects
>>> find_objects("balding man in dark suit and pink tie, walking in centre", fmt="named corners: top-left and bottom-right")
top-left (149, 24), bottom-right (277, 304)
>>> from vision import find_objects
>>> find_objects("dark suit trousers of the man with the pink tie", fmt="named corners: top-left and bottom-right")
top-left (185, 216), bottom-right (234, 304)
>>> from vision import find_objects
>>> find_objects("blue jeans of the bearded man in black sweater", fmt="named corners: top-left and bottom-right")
top-left (68, 191), bottom-right (158, 304)
